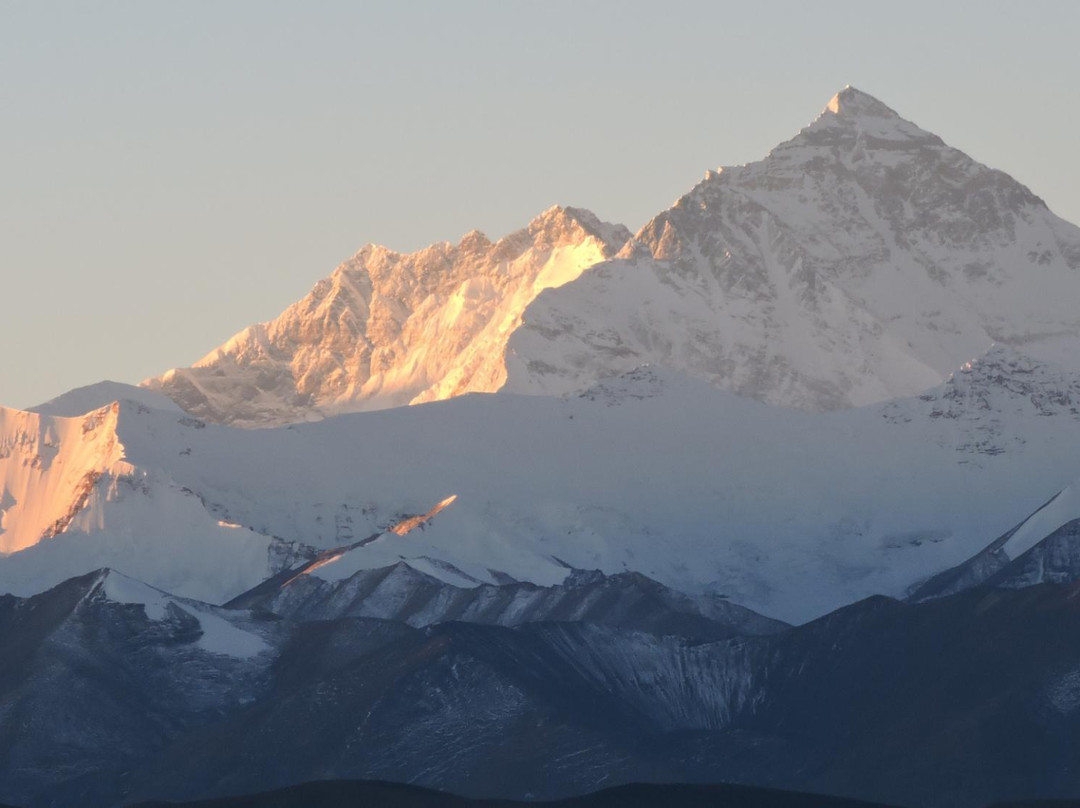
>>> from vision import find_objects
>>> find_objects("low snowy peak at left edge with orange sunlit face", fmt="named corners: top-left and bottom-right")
top-left (0, 402), bottom-right (271, 601)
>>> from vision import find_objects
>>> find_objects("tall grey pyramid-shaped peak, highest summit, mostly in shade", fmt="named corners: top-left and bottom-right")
top-left (505, 87), bottom-right (1080, 409)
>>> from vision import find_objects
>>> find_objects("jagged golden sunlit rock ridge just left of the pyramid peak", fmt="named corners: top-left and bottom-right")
top-left (144, 207), bottom-right (630, 426)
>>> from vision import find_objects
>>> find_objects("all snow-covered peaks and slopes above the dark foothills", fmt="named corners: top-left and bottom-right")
top-left (6, 87), bottom-right (1080, 622)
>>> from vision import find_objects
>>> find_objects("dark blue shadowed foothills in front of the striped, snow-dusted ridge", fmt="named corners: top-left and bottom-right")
top-left (6, 570), bottom-right (1080, 808)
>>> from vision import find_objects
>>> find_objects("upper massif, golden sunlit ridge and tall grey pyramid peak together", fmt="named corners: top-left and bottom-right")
top-left (137, 87), bottom-right (1080, 427)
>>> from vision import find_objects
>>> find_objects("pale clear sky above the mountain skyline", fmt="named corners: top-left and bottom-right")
top-left (0, 0), bottom-right (1080, 407)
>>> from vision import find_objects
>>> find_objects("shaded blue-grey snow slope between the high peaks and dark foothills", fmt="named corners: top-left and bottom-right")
top-left (6, 350), bottom-right (1080, 622)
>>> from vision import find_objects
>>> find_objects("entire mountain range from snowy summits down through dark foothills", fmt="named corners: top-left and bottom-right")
top-left (10, 80), bottom-right (1080, 808)
